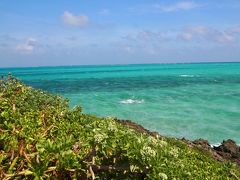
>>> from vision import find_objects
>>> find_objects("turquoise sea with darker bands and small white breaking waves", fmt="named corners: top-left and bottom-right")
top-left (0, 63), bottom-right (240, 144)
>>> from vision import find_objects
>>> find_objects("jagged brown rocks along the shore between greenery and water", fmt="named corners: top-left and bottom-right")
top-left (116, 119), bottom-right (240, 167)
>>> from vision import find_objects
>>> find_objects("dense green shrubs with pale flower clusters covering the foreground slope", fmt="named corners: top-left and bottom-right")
top-left (0, 76), bottom-right (240, 179)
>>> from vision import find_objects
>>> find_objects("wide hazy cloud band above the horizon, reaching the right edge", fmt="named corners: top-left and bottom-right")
top-left (119, 26), bottom-right (240, 56)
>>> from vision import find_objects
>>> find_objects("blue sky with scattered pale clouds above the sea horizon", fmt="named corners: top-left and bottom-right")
top-left (0, 0), bottom-right (240, 67)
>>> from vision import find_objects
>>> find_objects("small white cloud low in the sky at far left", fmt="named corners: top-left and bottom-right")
top-left (16, 37), bottom-right (37, 53)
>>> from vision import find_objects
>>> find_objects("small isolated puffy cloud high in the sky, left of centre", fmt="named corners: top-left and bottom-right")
top-left (62, 11), bottom-right (89, 27)
